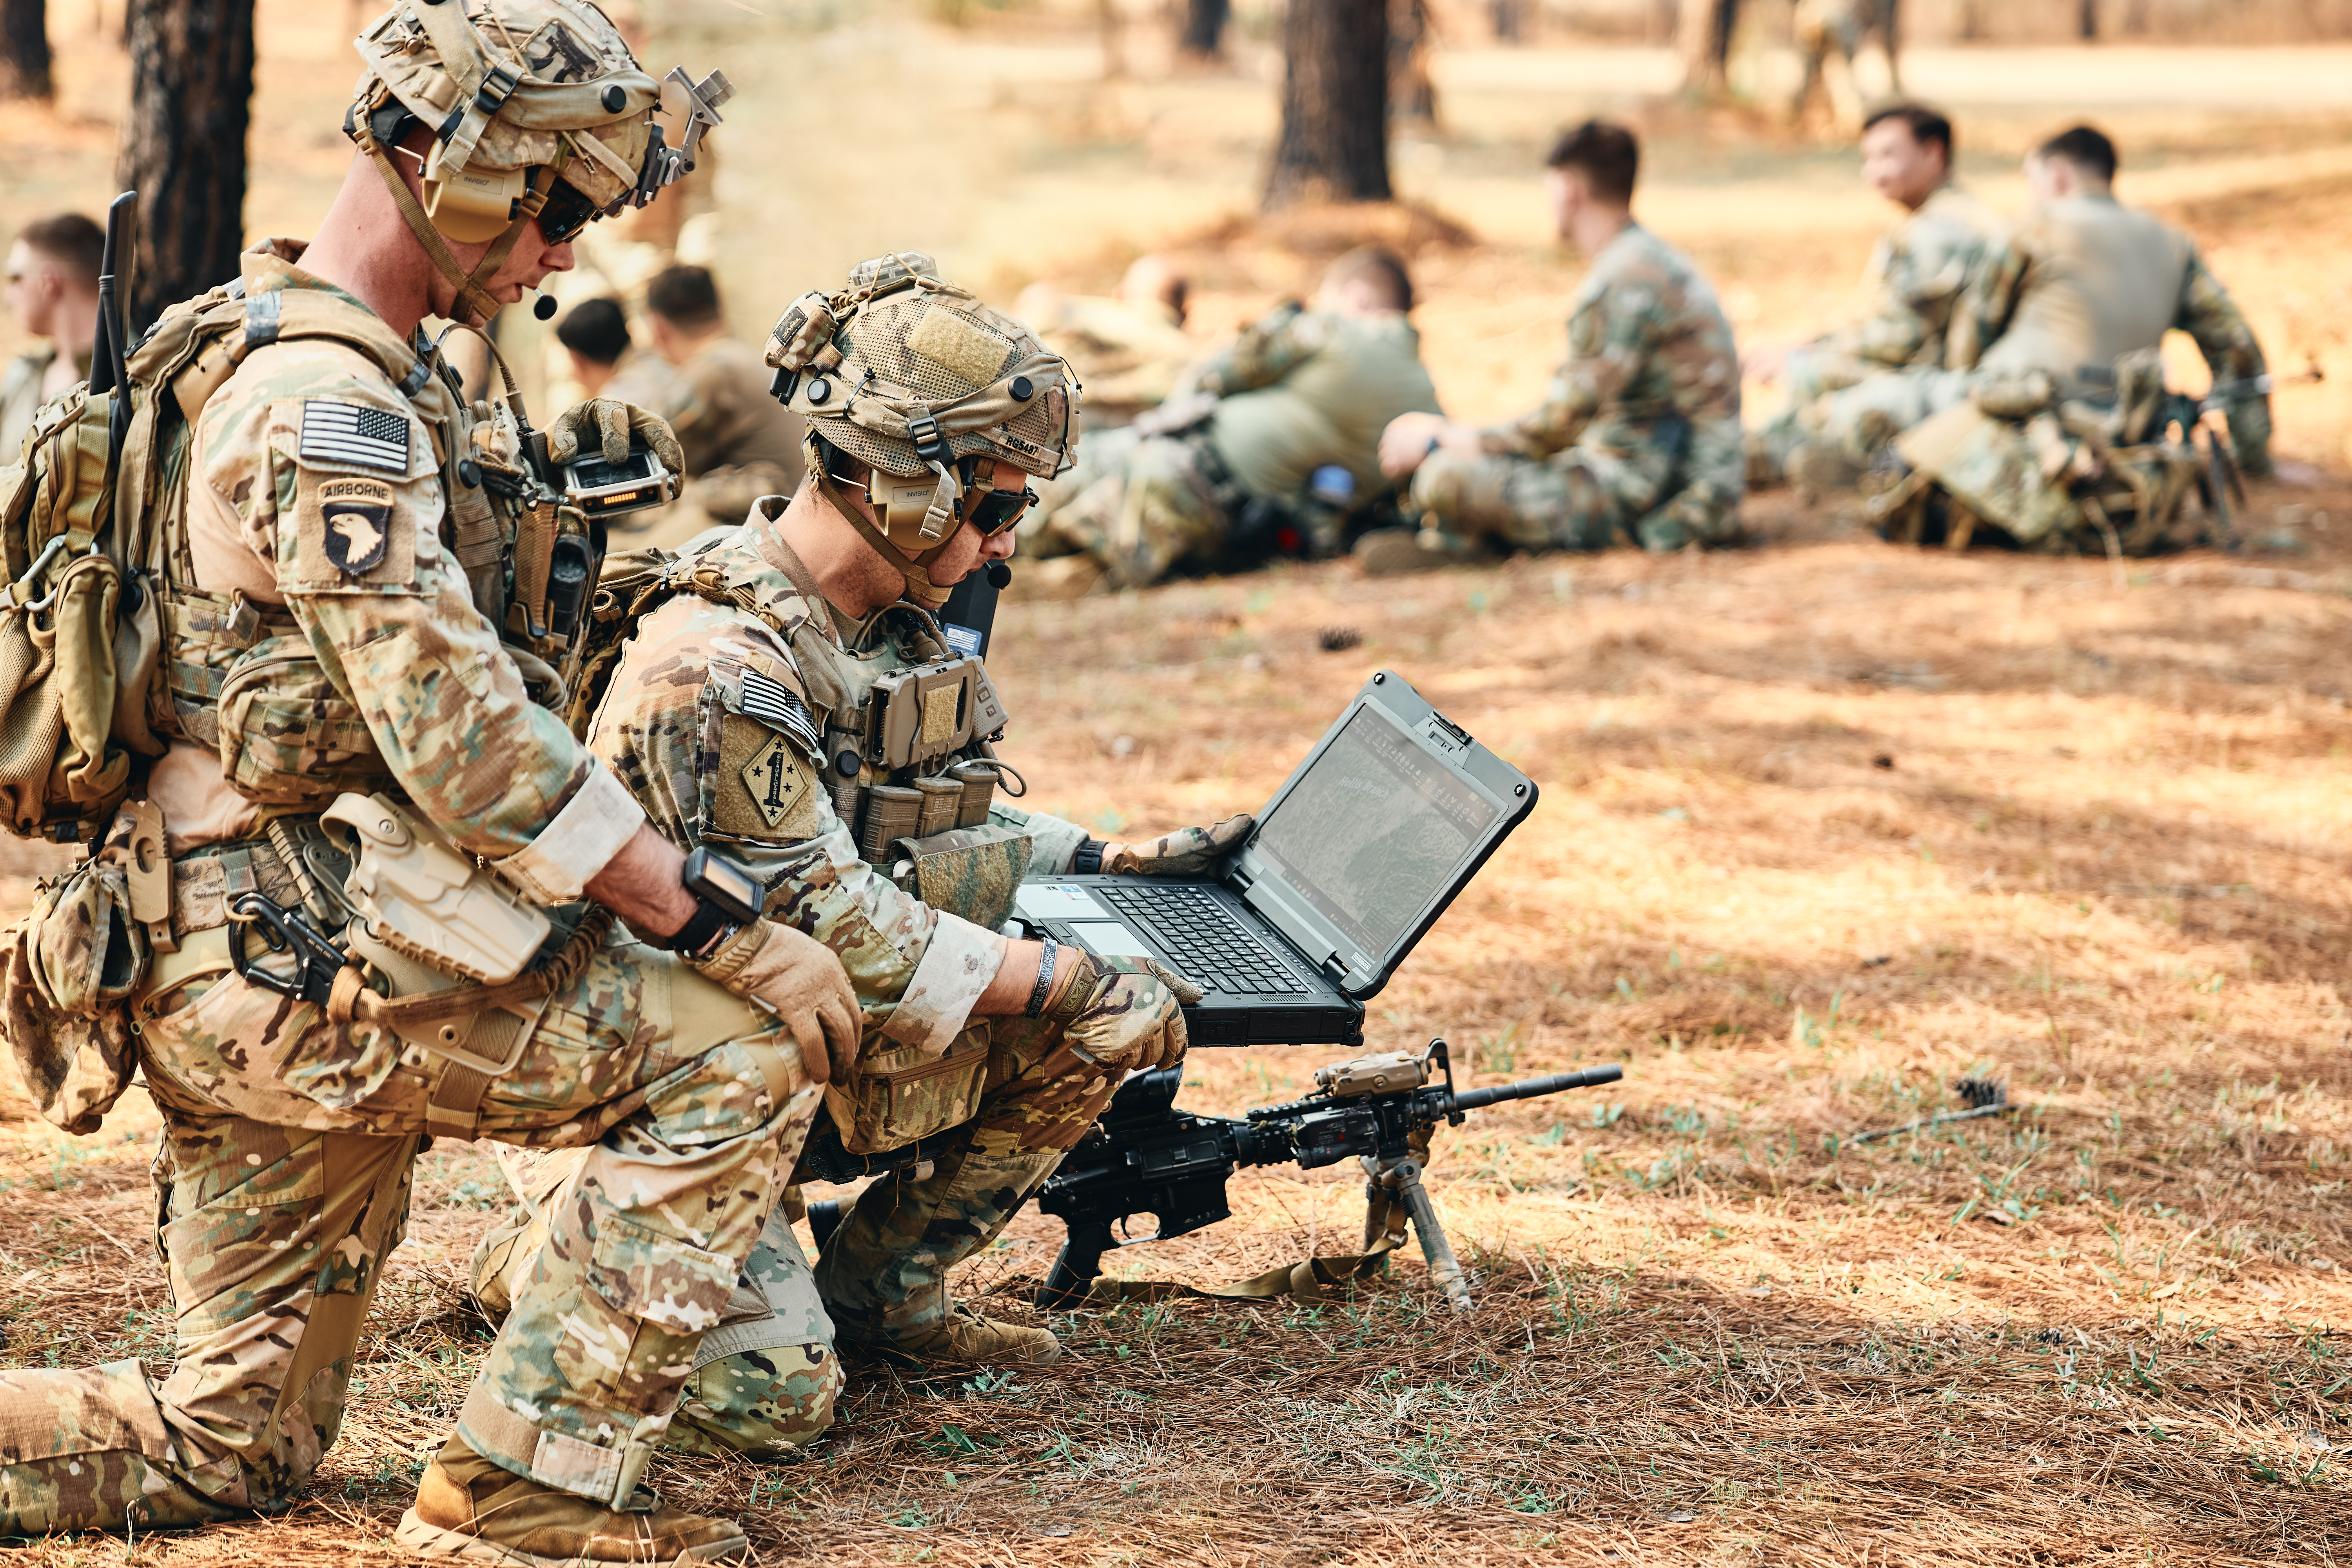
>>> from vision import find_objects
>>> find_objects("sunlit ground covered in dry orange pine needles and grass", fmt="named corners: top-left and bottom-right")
top-left (0, 12), bottom-right (2352, 1568)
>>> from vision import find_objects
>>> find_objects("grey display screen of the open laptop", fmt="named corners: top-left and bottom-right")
top-left (1254, 703), bottom-right (1503, 955)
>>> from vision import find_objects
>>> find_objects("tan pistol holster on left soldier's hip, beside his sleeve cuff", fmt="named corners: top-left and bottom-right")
top-left (320, 795), bottom-right (553, 985)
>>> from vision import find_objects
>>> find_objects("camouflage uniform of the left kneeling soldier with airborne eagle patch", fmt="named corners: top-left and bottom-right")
top-left (0, 247), bottom-right (821, 1535)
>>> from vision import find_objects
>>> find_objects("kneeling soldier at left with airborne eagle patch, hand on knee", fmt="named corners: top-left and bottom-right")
top-left (0, 0), bottom-right (856, 1563)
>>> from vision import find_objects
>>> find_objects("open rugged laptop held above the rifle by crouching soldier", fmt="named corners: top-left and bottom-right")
top-left (1014, 670), bottom-right (1536, 1046)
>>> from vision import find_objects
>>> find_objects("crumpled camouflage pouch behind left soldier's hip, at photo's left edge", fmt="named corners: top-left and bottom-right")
top-left (0, 860), bottom-right (151, 1133)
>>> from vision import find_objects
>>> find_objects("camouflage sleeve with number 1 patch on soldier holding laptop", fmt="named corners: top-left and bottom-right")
top-left (588, 595), bottom-right (1004, 1051)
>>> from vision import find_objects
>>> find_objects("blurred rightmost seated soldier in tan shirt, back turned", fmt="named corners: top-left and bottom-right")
top-left (1809, 125), bottom-right (2270, 475)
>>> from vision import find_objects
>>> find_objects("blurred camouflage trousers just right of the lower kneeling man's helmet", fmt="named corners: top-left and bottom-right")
top-left (1021, 425), bottom-right (1237, 588)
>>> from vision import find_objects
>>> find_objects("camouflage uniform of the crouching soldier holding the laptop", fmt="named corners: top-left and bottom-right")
top-left (475, 524), bottom-right (1122, 1453)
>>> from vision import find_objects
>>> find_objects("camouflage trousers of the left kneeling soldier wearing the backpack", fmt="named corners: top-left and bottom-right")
top-left (0, 931), bottom-right (818, 1535)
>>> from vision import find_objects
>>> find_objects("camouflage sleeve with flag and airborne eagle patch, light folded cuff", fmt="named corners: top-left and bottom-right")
top-left (198, 343), bottom-right (644, 903)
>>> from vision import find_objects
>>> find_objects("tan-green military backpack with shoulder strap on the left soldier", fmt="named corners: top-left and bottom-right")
top-left (0, 257), bottom-right (430, 844)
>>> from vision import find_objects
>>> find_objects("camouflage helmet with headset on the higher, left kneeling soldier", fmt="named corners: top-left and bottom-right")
top-left (343, 0), bottom-right (734, 322)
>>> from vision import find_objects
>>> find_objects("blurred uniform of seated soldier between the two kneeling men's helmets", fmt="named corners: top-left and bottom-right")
top-left (607, 336), bottom-right (802, 545)
